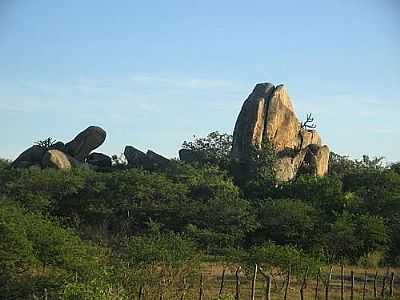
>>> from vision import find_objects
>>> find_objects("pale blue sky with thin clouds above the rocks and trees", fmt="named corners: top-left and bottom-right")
top-left (0, 0), bottom-right (400, 161)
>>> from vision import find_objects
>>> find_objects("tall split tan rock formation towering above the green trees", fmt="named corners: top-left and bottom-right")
top-left (232, 83), bottom-right (330, 181)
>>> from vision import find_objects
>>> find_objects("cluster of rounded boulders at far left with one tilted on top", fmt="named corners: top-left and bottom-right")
top-left (12, 126), bottom-right (111, 170)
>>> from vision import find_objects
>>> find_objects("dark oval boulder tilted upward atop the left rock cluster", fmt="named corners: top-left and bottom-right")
top-left (65, 126), bottom-right (106, 162)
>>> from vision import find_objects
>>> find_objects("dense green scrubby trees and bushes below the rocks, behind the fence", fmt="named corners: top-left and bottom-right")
top-left (0, 133), bottom-right (400, 299)
